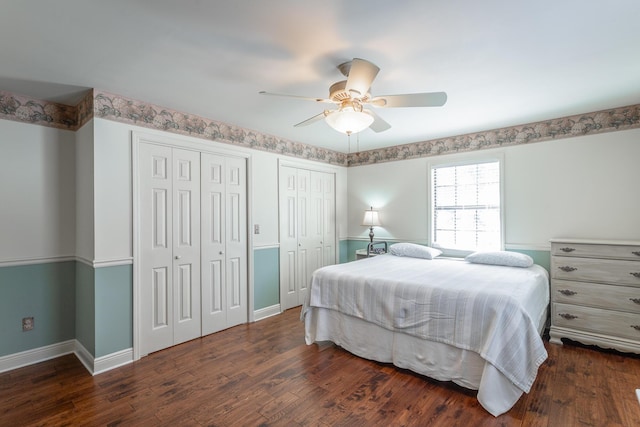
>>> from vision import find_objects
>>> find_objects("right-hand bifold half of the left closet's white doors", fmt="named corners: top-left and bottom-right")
top-left (202, 153), bottom-right (248, 335)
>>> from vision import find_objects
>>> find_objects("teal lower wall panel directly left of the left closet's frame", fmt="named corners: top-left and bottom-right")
top-left (93, 265), bottom-right (133, 357)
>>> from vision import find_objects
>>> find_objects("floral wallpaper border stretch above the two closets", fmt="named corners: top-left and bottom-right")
top-left (93, 91), bottom-right (347, 166)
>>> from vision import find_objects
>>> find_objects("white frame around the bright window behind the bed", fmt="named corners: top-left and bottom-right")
top-left (427, 152), bottom-right (506, 257)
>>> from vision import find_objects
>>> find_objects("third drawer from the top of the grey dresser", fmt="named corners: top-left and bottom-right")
top-left (551, 280), bottom-right (640, 314)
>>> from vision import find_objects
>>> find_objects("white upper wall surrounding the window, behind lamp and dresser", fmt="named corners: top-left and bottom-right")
top-left (347, 129), bottom-right (640, 250)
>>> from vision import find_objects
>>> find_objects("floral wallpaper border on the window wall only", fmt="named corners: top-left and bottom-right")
top-left (347, 104), bottom-right (640, 166)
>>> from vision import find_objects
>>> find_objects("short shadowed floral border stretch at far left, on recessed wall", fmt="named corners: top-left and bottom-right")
top-left (0, 91), bottom-right (78, 130)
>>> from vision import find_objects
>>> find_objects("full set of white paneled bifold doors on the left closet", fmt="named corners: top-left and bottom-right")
top-left (137, 143), bottom-right (249, 355)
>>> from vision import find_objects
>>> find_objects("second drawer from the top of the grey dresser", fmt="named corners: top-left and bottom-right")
top-left (551, 256), bottom-right (640, 286)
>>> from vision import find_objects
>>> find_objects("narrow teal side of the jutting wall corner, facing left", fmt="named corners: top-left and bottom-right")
top-left (75, 262), bottom-right (96, 356)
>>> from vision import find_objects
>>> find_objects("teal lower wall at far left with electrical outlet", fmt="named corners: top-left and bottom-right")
top-left (0, 261), bottom-right (76, 356)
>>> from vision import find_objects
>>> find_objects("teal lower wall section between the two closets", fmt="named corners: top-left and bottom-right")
top-left (253, 248), bottom-right (280, 310)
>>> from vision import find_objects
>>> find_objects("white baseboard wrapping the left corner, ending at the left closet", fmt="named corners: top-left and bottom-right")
top-left (0, 340), bottom-right (133, 375)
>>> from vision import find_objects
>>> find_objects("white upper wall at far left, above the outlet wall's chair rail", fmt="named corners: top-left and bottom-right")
top-left (0, 120), bottom-right (75, 262)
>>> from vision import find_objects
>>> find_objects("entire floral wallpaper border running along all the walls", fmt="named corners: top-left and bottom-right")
top-left (0, 89), bottom-right (640, 167)
